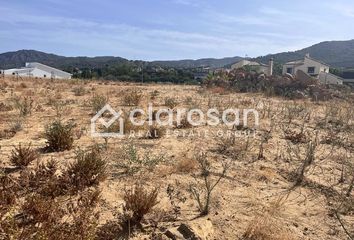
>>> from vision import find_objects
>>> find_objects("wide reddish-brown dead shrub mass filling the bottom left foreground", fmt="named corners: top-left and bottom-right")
top-left (11, 190), bottom-right (100, 240)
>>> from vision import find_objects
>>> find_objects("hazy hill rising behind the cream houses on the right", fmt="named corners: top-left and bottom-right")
top-left (255, 40), bottom-right (354, 68)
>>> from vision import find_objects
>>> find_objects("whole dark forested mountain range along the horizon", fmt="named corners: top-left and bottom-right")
top-left (0, 40), bottom-right (354, 69)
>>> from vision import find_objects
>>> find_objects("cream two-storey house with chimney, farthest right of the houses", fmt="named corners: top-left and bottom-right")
top-left (283, 54), bottom-right (343, 84)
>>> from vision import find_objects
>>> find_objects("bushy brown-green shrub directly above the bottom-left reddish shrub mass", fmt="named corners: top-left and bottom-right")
top-left (63, 149), bottom-right (107, 192)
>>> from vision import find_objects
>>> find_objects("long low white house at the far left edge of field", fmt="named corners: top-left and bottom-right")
top-left (4, 62), bottom-right (72, 79)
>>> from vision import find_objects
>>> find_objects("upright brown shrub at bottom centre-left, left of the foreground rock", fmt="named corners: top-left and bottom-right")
top-left (123, 185), bottom-right (158, 224)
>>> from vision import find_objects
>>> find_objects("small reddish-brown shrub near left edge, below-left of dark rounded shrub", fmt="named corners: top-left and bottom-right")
top-left (10, 144), bottom-right (38, 168)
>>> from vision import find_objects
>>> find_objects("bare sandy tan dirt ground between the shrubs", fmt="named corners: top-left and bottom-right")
top-left (0, 78), bottom-right (354, 240)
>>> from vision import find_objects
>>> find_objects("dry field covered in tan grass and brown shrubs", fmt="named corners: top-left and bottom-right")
top-left (0, 78), bottom-right (354, 240)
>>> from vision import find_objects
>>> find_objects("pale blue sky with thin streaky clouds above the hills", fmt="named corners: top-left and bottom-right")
top-left (0, 0), bottom-right (354, 60)
